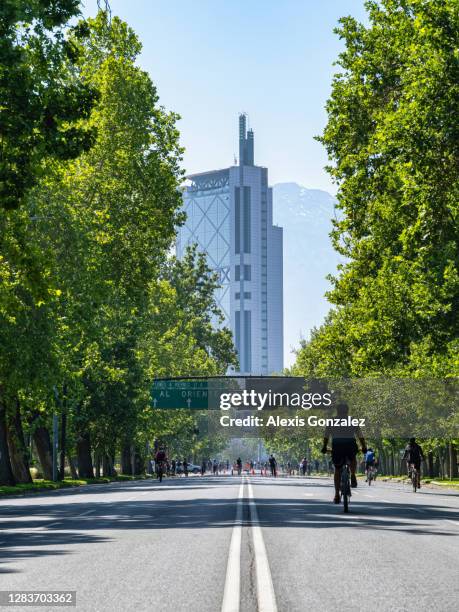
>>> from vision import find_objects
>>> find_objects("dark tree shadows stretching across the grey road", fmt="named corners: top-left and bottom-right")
top-left (0, 478), bottom-right (459, 573)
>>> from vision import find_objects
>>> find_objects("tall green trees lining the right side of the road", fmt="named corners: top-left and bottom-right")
top-left (293, 0), bottom-right (459, 476)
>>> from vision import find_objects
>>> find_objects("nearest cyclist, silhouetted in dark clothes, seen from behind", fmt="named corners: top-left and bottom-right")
top-left (322, 402), bottom-right (367, 504)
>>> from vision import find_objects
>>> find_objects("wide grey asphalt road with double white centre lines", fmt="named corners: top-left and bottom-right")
top-left (0, 476), bottom-right (459, 612)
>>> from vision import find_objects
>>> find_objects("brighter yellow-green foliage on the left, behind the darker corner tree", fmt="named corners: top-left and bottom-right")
top-left (0, 12), bottom-right (235, 482)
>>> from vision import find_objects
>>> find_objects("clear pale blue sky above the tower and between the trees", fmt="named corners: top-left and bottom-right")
top-left (84, 0), bottom-right (365, 193)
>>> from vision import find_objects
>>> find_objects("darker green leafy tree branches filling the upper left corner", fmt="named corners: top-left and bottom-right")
top-left (0, 0), bottom-right (95, 209)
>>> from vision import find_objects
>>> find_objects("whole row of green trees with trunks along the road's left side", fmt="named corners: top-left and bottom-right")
top-left (0, 0), bottom-right (236, 484)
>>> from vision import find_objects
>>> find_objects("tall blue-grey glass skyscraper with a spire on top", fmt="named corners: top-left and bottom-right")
top-left (177, 115), bottom-right (283, 375)
